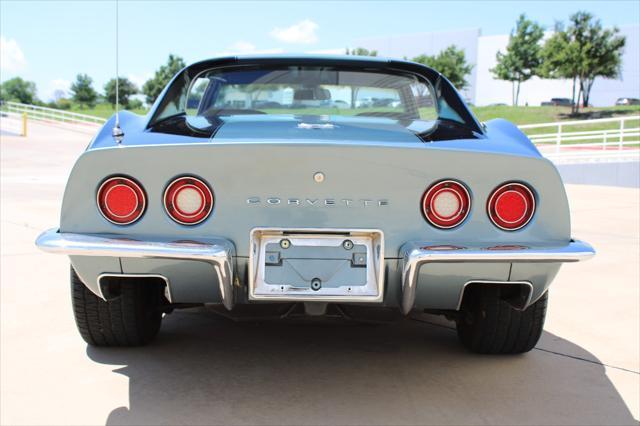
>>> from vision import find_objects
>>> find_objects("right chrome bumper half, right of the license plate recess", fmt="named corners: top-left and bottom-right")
top-left (400, 240), bottom-right (595, 314)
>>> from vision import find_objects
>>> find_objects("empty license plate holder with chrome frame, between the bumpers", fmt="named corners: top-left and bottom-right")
top-left (249, 228), bottom-right (384, 303)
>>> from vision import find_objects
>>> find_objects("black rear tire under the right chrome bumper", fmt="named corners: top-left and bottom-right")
top-left (456, 291), bottom-right (548, 354)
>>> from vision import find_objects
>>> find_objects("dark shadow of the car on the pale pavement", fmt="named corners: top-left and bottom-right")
top-left (87, 310), bottom-right (636, 425)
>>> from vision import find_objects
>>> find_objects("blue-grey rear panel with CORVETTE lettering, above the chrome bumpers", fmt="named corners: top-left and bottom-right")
top-left (60, 115), bottom-right (570, 258)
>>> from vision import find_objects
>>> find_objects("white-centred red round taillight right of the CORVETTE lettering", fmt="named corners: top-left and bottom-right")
top-left (422, 180), bottom-right (471, 229)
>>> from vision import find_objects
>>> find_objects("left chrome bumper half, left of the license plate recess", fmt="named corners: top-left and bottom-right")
top-left (36, 229), bottom-right (235, 309)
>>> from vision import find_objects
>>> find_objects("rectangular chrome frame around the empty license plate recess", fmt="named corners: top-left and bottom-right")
top-left (248, 228), bottom-right (385, 303)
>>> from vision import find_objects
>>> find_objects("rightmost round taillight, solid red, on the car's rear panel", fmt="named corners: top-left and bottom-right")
top-left (487, 182), bottom-right (536, 231)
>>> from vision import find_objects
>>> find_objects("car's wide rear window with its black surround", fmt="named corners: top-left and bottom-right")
top-left (147, 58), bottom-right (483, 142)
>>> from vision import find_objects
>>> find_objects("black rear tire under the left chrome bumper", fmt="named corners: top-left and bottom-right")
top-left (71, 267), bottom-right (163, 347)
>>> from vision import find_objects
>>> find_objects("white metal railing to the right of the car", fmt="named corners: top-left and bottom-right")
top-left (519, 115), bottom-right (640, 162)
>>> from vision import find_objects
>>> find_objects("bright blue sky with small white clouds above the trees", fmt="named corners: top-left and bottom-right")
top-left (0, 0), bottom-right (640, 100)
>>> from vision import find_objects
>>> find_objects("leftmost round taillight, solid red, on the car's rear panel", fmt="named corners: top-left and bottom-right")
top-left (97, 176), bottom-right (147, 225)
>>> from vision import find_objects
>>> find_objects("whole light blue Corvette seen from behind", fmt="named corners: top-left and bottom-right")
top-left (37, 57), bottom-right (594, 353)
